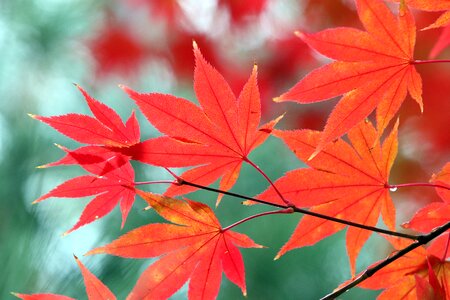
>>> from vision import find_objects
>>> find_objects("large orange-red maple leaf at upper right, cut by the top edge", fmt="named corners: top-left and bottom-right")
top-left (274, 0), bottom-right (422, 157)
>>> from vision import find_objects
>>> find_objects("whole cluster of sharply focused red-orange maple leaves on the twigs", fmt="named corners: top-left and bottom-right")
top-left (21, 0), bottom-right (450, 299)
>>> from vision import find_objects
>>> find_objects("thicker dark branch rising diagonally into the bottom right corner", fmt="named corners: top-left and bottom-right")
top-left (321, 222), bottom-right (450, 300)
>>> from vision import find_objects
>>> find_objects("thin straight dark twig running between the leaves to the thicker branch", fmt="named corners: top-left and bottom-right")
top-left (182, 181), bottom-right (418, 240)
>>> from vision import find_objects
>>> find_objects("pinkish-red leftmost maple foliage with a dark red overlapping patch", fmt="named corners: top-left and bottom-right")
top-left (32, 86), bottom-right (140, 234)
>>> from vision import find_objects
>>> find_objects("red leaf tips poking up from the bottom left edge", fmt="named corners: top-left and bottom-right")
top-left (12, 256), bottom-right (116, 300)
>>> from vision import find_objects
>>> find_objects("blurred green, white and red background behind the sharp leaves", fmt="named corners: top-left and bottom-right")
top-left (0, 0), bottom-right (450, 299)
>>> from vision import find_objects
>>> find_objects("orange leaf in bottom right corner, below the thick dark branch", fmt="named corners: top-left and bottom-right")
top-left (358, 238), bottom-right (450, 300)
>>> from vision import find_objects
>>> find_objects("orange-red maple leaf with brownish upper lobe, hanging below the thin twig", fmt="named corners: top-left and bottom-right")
top-left (87, 191), bottom-right (262, 299)
